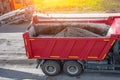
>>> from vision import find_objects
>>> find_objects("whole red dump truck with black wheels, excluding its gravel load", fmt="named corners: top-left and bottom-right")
top-left (23, 14), bottom-right (120, 76)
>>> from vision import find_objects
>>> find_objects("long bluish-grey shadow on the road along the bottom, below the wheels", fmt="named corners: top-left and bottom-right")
top-left (0, 68), bottom-right (120, 80)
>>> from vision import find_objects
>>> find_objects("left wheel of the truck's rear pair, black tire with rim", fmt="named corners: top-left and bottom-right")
top-left (42, 60), bottom-right (60, 76)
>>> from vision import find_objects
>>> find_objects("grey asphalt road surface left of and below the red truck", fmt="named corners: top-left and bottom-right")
top-left (0, 22), bottom-right (120, 80)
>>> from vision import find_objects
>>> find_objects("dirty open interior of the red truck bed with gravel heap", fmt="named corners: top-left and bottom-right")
top-left (34, 23), bottom-right (109, 37)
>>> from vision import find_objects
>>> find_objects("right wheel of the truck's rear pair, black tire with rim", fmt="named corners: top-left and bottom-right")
top-left (63, 61), bottom-right (83, 76)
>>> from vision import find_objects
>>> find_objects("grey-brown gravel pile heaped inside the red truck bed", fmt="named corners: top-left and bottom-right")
top-left (54, 27), bottom-right (102, 37)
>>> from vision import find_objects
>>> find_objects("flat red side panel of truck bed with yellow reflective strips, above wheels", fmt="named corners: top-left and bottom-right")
top-left (28, 38), bottom-right (114, 60)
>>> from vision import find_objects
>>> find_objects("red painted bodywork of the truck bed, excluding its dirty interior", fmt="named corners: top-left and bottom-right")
top-left (23, 16), bottom-right (120, 60)
